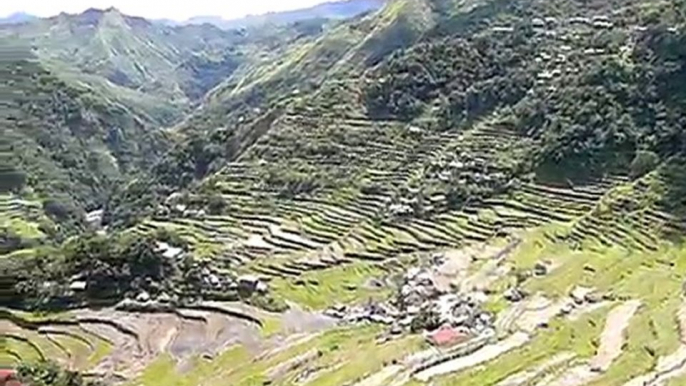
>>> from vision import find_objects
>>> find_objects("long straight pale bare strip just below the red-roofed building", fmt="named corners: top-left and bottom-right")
top-left (414, 332), bottom-right (530, 382)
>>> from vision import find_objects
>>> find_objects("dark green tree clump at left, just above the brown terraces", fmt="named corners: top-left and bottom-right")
top-left (1, 231), bottom-right (202, 309)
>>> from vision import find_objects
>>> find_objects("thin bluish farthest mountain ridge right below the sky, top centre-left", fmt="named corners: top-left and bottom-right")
top-left (182, 0), bottom-right (386, 29)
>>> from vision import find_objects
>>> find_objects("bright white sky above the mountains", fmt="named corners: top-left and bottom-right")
top-left (0, 0), bottom-right (340, 21)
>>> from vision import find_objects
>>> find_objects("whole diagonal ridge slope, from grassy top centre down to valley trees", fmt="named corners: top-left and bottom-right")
top-left (101, 0), bottom-right (433, 225)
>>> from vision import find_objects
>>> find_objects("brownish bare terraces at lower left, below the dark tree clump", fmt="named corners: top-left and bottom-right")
top-left (0, 303), bottom-right (332, 381)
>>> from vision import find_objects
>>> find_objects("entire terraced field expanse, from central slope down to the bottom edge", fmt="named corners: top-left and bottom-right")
top-left (5, 20), bottom-right (686, 386)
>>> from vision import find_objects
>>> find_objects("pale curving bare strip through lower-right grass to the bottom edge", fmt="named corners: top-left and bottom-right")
top-left (537, 300), bottom-right (641, 386)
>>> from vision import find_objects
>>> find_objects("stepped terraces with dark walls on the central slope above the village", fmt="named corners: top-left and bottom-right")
top-left (130, 109), bottom-right (544, 276)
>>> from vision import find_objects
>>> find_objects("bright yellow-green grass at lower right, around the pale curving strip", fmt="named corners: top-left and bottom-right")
top-left (432, 225), bottom-right (686, 386)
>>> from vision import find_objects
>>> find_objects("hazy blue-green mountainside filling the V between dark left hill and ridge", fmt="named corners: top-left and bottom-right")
top-left (0, 8), bottom-right (334, 125)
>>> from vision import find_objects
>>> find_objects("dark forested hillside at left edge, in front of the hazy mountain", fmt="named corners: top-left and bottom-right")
top-left (0, 44), bottom-right (168, 238)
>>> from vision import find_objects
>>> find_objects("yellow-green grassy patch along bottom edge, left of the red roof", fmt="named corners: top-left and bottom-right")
top-left (131, 327), bottom-right (421, 386)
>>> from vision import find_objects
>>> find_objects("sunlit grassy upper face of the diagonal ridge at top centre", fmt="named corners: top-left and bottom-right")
top-left (187, 0), bottom-right (433, 133)
